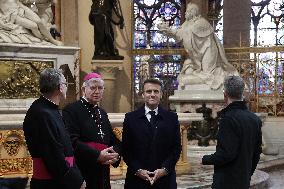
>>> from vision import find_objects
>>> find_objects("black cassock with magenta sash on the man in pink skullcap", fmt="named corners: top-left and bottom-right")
top-left (62, 98), bottom-right (120, 189)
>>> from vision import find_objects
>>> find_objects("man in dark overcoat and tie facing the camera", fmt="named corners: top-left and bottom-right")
top-left (122, 79), bottom-right (181, 189)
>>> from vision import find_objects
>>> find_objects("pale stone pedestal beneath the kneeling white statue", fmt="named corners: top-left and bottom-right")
top-left (169, 85), bottom-right (224, 118)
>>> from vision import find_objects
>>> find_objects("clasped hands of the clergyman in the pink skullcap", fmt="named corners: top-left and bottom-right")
top-left (98, 146), bottom-right (119, 165)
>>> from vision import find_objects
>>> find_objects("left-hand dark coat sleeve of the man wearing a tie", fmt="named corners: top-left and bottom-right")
top-left (122, 114), bottom-right (141, 174)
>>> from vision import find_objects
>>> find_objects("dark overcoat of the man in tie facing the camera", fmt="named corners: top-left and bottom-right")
top-left (122, 106), bottom-right (181, 189)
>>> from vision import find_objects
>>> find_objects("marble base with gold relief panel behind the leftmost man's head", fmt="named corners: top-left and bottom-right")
top-left (0, 44), bottom-right (80, 113)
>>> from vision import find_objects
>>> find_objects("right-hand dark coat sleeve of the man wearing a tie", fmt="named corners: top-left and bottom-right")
top-left (162, 114), bottom-right (181, 172)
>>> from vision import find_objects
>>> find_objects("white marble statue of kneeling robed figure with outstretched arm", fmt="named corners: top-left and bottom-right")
top-left (158, 3), bottom-right (238, 90)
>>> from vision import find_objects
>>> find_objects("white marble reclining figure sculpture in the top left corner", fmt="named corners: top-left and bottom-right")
top-left (0, 0), bottom-right (62, 45)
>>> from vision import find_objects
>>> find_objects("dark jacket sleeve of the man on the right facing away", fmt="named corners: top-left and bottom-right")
top-left (202, 118), bottom-right (240, 166)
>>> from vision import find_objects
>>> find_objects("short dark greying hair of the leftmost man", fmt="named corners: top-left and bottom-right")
top-left (39, 68), bottom-right (64, 94)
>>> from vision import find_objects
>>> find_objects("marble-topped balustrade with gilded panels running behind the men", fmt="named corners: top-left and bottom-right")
top-left (0, 112), bottom-right (203, 179)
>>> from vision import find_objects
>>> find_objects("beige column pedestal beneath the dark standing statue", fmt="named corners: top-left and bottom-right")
top-left (92, 60), bottom-right (123, 112)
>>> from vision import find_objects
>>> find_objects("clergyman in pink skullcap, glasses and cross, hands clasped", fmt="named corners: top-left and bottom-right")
top-left (63, 73), bottom-right (120, 189)
